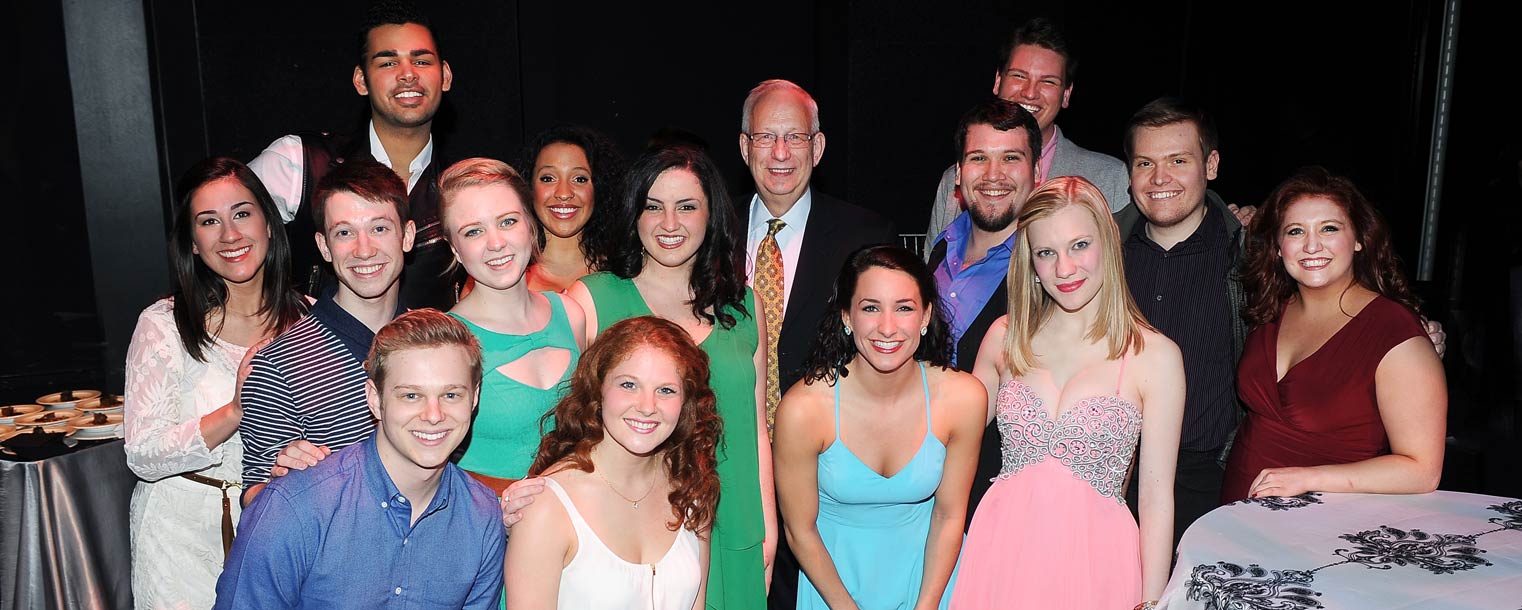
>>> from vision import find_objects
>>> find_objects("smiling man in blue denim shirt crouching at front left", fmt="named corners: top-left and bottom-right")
top-left (216, 309), bottom-right (507, 610)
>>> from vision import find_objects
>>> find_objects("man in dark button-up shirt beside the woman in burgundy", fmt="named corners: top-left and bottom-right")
top-left (1116, 97), bottom-right (1247, 539)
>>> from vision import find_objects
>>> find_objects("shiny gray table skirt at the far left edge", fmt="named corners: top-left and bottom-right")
top-left (0, 441), bottom-right (137, 610)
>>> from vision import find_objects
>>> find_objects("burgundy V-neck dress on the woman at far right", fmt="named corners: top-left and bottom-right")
top-left (1221, 297), bottom-right (1426, 502)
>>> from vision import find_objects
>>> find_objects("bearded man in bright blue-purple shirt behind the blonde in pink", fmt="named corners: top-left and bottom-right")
top-left (930, 99), bottom-right (1041, 523)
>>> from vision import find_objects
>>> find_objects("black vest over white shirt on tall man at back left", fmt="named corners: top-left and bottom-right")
top-left (286, 131), bottom-right (458, 310)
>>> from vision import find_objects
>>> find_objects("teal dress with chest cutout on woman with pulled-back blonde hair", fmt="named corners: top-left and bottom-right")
top-left (451, 292), bottom-right (581, 479)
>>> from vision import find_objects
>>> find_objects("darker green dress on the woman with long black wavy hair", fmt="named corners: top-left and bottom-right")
top-left (581, 272), bottom-right (766, 610)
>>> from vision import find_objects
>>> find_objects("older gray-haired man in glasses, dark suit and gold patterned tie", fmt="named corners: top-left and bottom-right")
top-left (738, 79), bottom-right (896, 608)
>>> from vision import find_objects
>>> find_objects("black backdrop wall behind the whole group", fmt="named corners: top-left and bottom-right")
top-left (11, 0), bottom-right (1522, 489)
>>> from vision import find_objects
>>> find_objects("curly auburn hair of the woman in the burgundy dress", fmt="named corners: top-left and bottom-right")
top-left (1242, 166), bottom-right (1422, 326)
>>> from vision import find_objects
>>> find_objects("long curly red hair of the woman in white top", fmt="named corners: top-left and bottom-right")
top-left (528, 316), bottom-right (723, 532)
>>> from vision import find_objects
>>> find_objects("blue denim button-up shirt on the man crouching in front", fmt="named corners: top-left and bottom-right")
top-left (216, 437), bottom-right (507, 610)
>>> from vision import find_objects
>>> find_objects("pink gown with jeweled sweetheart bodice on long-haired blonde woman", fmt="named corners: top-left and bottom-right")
top-left (951, 380), bottom-right (1142, 610)
